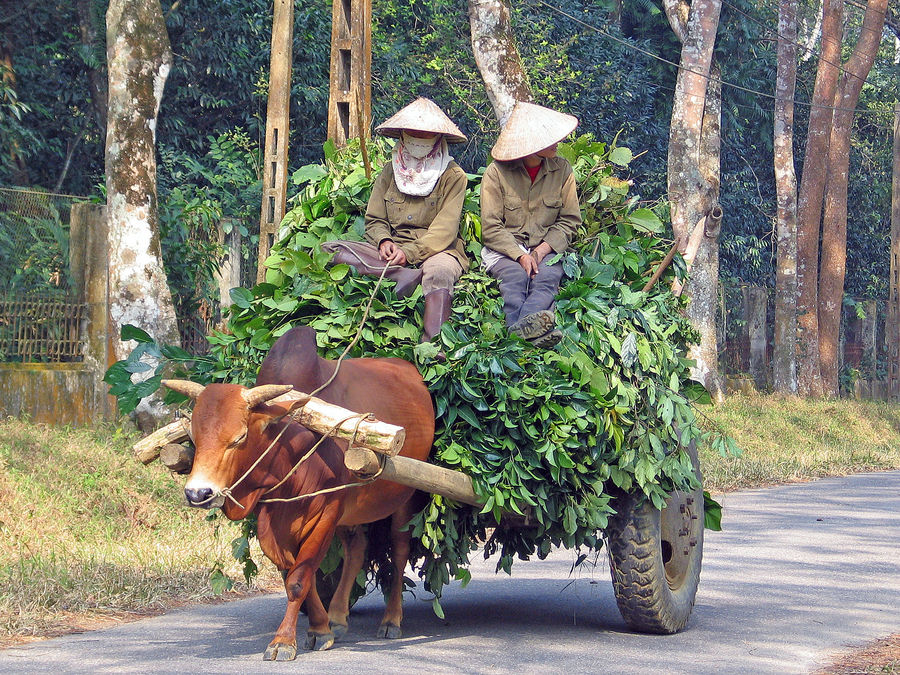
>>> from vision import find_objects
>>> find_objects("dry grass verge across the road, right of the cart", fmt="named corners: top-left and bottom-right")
top-left (701, 395), bottom-right (900, 492)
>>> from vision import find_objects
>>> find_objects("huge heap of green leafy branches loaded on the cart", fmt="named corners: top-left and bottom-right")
top-left (190, 137), bottom-right (724, 610)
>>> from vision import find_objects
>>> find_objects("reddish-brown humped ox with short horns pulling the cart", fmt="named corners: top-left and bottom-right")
top-left (166, 328), bottom-right (434, 661)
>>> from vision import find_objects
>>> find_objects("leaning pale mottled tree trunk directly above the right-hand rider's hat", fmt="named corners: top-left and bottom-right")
top-left (469, 0), bottom-right (532, 127)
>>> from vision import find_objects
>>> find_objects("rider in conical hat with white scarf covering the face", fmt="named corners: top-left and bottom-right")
top-left (322, 98), bottom-right (469, 352)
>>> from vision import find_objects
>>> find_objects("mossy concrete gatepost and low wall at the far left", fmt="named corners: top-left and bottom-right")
top-left (0, 204), bottom-right (115, 426)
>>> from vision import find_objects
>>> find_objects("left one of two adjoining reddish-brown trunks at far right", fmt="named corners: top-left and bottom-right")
top-left (797, 0), bottom-right (843, 396)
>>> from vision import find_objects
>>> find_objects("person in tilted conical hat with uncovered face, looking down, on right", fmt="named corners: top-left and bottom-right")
top-left (481, 101), bottom-right (581, 348)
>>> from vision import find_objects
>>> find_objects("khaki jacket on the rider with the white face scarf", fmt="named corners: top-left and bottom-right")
top-left (366, 162), bottom-right (469, 270)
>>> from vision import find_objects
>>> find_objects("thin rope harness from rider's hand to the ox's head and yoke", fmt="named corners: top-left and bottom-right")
top-left (197, 256), bottom-right (391, 509)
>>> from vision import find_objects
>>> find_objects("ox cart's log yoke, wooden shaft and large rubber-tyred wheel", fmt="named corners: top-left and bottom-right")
top-left (134, 390), bottom-right (704, 633)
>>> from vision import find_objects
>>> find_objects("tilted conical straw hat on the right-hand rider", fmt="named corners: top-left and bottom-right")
top-left (491, 101), bottom-right (578, 162)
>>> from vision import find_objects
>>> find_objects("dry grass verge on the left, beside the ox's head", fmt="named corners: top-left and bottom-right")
top-left (0, 419), bottom-right (274, 643)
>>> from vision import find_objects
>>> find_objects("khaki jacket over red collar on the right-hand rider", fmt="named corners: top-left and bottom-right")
top-left (481, 157), bottom-right (581, 260)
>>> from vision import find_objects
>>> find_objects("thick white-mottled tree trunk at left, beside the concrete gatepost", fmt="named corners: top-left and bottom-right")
top-left (106, 0), bottom-right (180, 426)
